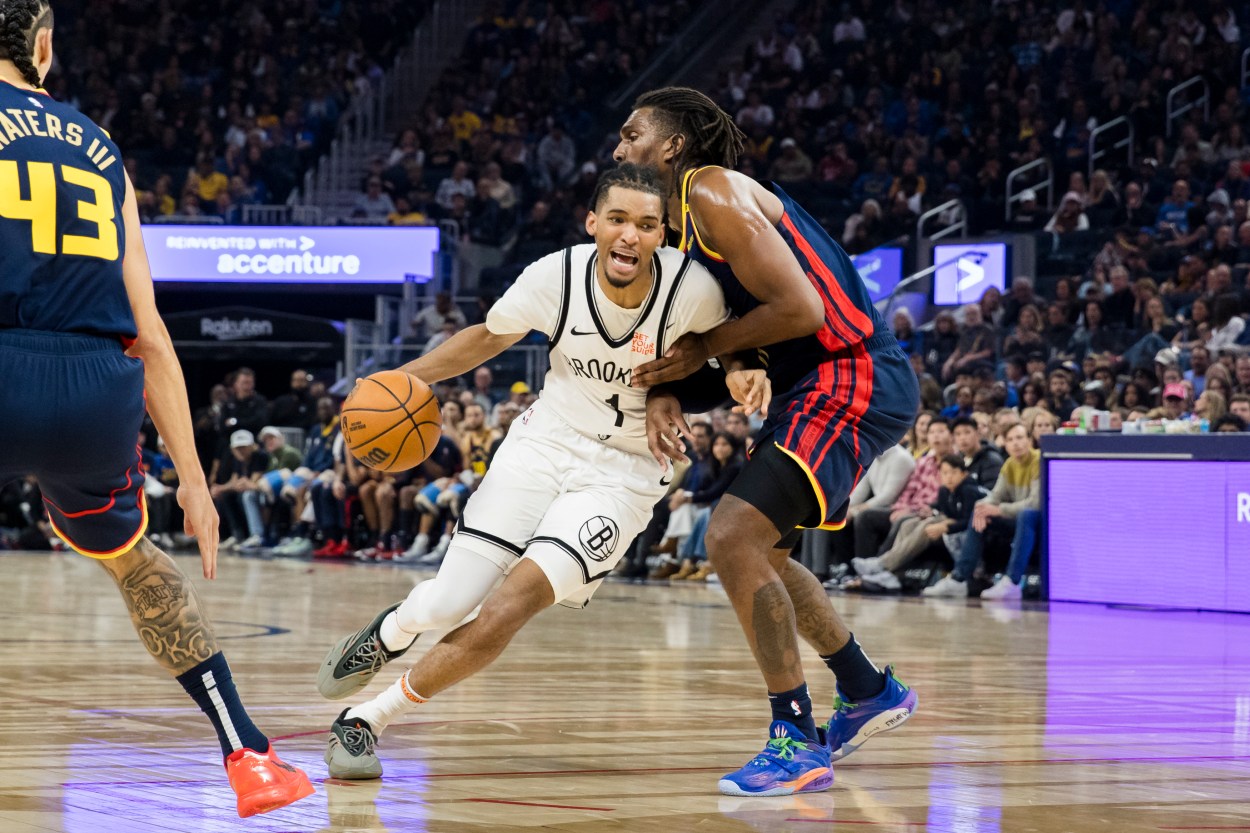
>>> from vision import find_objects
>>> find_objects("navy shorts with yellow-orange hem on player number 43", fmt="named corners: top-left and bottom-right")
top-left (0, 330), bottom-right (148, 559)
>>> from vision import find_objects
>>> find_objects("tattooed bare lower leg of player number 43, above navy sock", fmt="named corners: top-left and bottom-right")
top-left (100, 538), bottom-right (220, 675)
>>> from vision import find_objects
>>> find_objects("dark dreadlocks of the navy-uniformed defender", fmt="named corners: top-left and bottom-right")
top-left (634, 86), bottom-right (746, 175)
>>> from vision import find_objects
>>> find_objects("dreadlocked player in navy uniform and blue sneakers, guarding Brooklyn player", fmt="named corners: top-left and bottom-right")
top-left (614, 88), bottom-right (919, 795)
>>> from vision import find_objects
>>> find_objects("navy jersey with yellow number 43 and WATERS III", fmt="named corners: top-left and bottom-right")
top-left (0, 81), bottom-right (136, 339)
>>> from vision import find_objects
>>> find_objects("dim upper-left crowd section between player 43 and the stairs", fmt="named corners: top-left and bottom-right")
top-left (49, 0), bottom-right (431, 221)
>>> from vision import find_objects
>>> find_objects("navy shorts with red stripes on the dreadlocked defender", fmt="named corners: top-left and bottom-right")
top-left (728, 334), bottom-right (920, 547)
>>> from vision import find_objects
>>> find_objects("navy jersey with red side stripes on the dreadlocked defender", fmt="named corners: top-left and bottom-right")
top-left (680, 168), bottom-right (889, 393)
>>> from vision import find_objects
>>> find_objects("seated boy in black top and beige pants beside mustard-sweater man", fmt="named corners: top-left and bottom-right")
top-left (851, 454), bottom-right (986, 593)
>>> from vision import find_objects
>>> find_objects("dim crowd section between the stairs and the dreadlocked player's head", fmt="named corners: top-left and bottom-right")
top-left (342, 0), bottom-right (704, 291)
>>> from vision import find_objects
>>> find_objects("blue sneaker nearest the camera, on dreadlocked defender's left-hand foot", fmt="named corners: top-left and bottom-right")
top-left (719, 720), bottom-right (834, 795)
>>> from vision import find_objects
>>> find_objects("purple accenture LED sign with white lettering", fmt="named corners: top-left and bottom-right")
top-left (143, 225), bottom-right (439, 284)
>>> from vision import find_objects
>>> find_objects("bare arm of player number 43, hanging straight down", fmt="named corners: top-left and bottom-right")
top-left (121, 176), bottom-right (219, 579)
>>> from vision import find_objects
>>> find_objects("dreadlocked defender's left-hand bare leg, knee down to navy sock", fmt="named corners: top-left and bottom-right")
top-left (705, 495), bottom-right (803, 692)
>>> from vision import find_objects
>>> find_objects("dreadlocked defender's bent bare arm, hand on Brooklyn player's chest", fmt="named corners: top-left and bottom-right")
top-left (634, 170), bottom-right (825, 386)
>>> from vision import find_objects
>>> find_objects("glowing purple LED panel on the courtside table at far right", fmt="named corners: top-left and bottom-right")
top-left (1046, 460), bottom-right (1250, 613)
